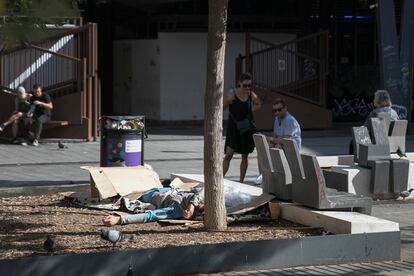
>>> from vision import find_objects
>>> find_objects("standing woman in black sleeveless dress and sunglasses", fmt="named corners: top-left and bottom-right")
top-left (223, 73), bottom-right (261, 183)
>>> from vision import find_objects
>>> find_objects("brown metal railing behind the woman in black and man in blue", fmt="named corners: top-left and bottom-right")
top-left (236, 31), bottom-right (328, 106)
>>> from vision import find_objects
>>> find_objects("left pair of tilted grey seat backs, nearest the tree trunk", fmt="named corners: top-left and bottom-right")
top-left (253, 134), bottom-right (292, 200)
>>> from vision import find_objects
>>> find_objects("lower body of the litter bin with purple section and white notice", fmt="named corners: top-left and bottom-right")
top-left (107, 138), bottom-right (142, 167)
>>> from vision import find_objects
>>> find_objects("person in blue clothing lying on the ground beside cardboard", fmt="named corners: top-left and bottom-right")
top-left (102, 185), bottom-right (202, 226)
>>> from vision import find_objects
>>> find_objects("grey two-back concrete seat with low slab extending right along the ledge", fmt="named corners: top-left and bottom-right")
top-left (283, 139), bottom-right (372, 214)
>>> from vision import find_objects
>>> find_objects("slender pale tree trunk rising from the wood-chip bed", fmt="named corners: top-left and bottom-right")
top-left (204, 0), bottom-right (228, 230)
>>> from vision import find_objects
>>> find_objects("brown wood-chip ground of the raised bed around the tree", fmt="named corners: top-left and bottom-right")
top-left (0, 194), bottom-right (322, 259)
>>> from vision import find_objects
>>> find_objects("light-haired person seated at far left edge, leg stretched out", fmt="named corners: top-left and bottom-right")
top-left (0, 86), bottom-right (31, 143)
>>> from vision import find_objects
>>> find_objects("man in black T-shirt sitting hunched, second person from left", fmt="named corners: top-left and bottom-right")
top-left (27, 84), bottom-right (53, 147)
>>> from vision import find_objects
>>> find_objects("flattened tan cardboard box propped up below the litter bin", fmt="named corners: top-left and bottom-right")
top-left (81, 166), bottom-right (162, 199)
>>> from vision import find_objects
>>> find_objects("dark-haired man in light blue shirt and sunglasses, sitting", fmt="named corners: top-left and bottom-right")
top-left (269, 98), bottom-right (302, 150)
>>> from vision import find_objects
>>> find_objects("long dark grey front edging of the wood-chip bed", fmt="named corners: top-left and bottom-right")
top-left (0, 232), bottom-right (400, 276)
